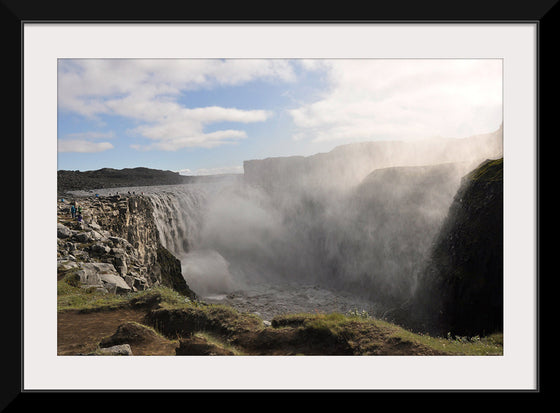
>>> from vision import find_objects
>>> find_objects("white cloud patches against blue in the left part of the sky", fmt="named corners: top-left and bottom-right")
top-left (58, 59), bottom-right (295, 150)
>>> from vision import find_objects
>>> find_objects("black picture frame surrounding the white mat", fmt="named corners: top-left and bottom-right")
top-left (9, 0), bottom-right (558, 411)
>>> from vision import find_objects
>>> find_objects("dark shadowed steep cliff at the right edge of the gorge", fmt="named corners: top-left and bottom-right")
top-left (401, 159), bottom-right (504, 336)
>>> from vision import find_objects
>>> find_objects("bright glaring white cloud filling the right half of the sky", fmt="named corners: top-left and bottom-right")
top-left (289, 59), bottom-right (502, 142)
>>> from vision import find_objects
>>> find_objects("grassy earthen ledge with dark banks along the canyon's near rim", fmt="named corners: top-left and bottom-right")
top-left (57, 274), bottom-right (503, 356)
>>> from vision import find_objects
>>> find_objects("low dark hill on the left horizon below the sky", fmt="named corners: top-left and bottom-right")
top-left (57, 167), bottom-right (238, 194)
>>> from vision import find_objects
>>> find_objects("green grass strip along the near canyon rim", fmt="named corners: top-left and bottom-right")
top-left (57, 274), bottom-right (503, 356)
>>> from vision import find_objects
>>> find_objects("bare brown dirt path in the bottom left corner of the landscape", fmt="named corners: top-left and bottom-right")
top-left (57, 309), bottom-right (178, 356)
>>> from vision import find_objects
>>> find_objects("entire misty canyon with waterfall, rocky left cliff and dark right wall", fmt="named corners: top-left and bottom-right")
top-left (58, 127), bottom-right (503, 348)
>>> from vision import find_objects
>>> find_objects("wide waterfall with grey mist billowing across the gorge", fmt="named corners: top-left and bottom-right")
top-left (141, 164), bottom-right (465, 301)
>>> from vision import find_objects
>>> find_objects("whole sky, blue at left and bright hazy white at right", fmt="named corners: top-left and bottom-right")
top-left (57, 59), bottom-right (502, 175)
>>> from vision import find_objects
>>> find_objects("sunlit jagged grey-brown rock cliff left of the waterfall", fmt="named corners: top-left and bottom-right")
top-left (57, 195), bottom-right (195, 298)
